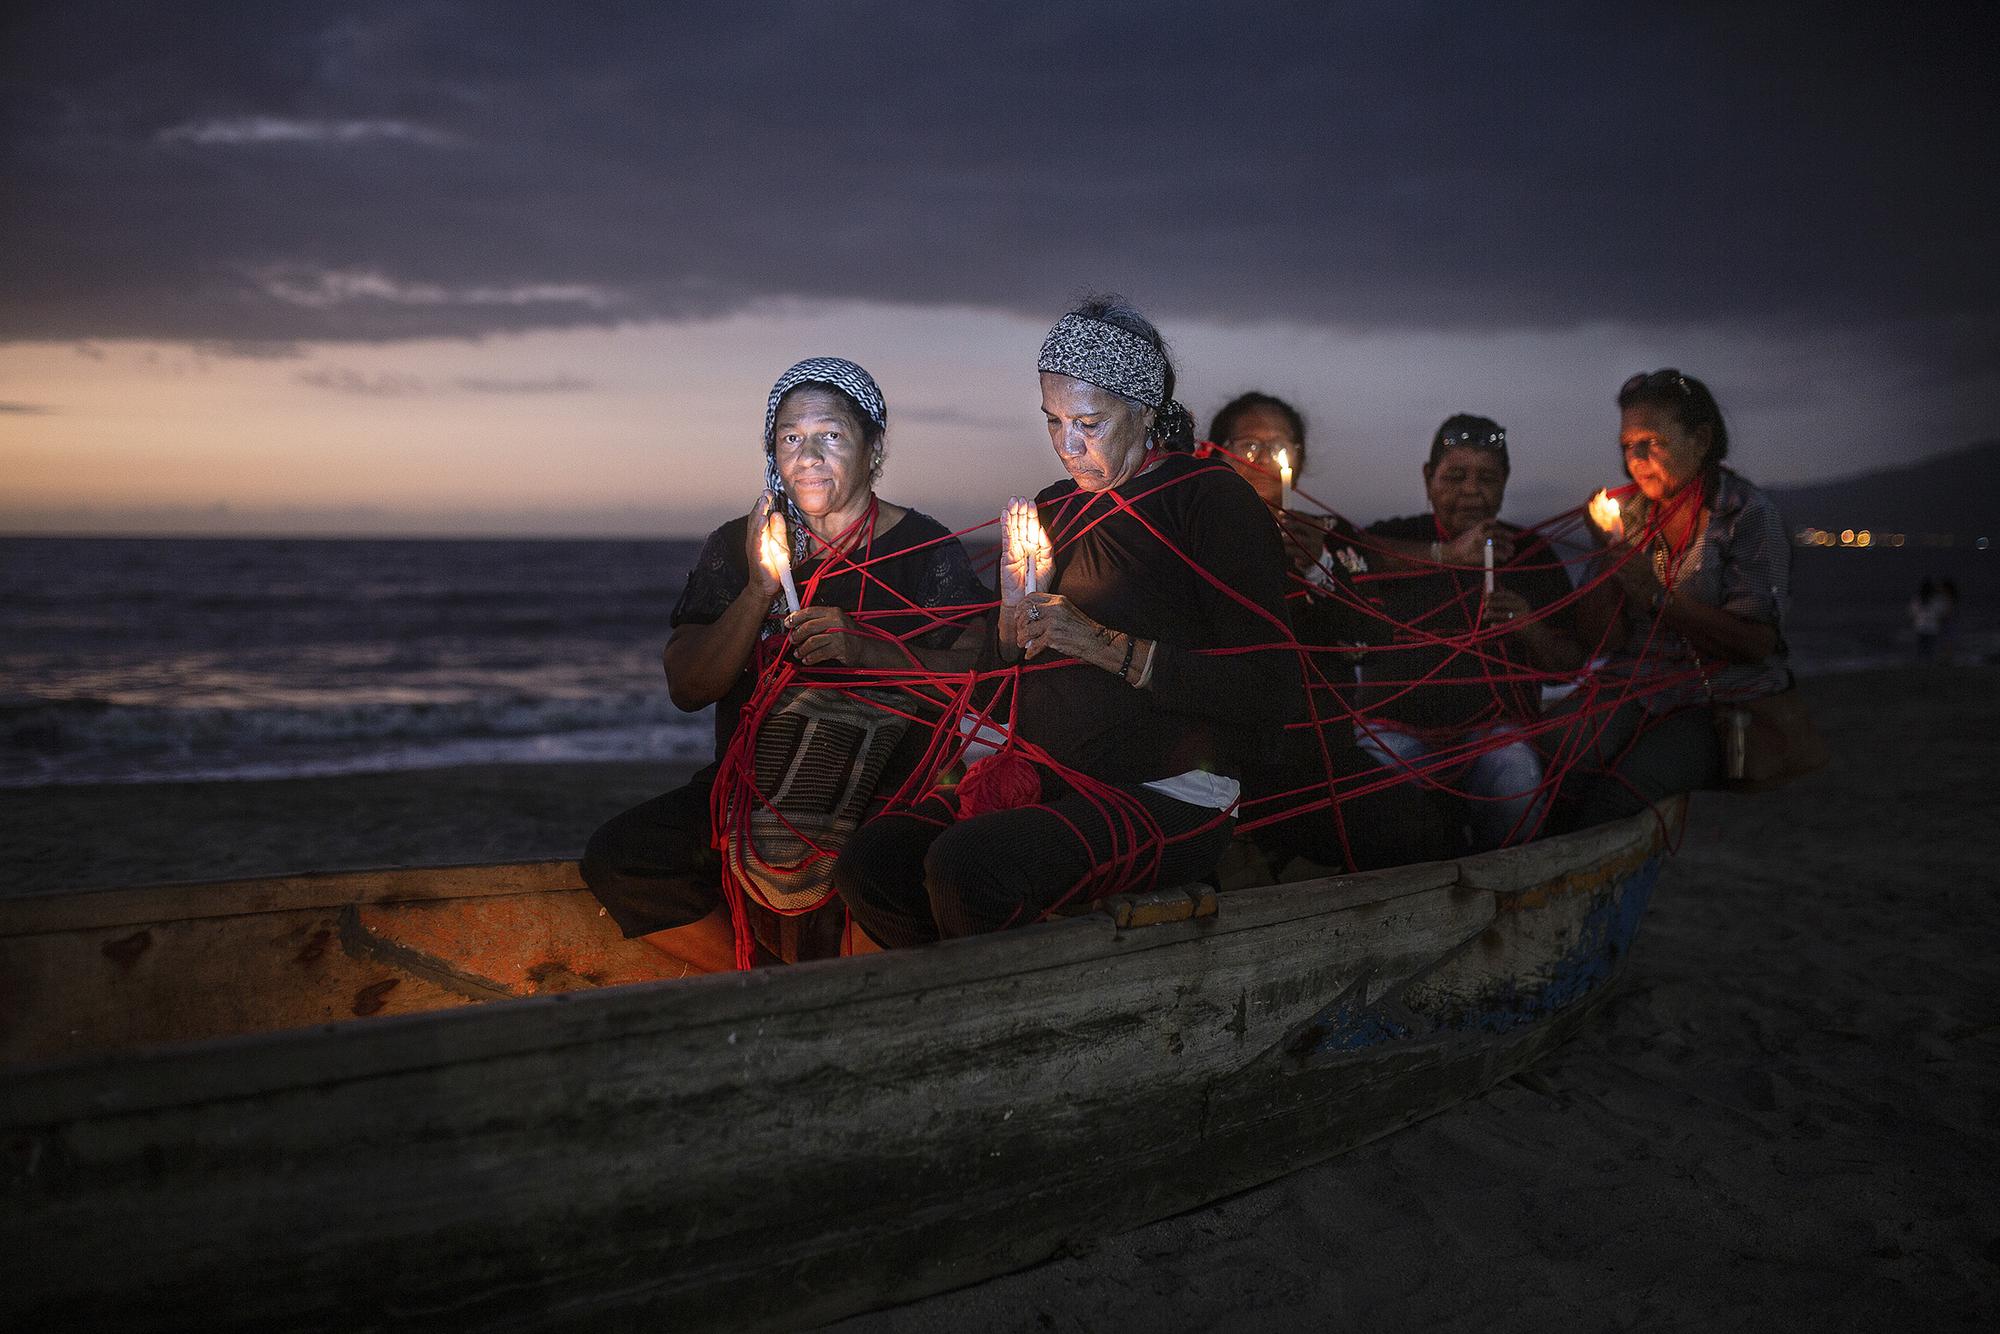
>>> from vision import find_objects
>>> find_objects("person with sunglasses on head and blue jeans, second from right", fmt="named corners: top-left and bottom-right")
top-left (1354, 412), bottom-right (1602, 852)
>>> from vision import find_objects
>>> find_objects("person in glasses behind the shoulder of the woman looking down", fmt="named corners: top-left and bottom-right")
top-left (1208, 390), bottom-right (1456, 870)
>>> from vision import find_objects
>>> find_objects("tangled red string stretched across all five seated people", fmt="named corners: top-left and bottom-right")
top-left (710, 446), bottom-right (1712, 968)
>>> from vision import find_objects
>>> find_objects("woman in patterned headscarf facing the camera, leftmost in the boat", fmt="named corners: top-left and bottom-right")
top-left (582, 356), bottom-right (992, 972)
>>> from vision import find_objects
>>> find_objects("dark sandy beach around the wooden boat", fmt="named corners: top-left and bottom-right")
top-left (0, 668), bottom-right (2000, 1334)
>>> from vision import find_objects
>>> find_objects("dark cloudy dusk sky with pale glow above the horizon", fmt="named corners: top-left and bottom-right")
top-left (0, 0), bottom-right (2000, 532)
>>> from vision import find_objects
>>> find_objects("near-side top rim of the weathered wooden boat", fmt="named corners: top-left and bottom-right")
top-left (0, 804), bottom-right (1674, 1132)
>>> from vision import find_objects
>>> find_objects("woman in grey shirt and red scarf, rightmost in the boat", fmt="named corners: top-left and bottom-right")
top-left (1556, 368), bottom-right (1792, 826)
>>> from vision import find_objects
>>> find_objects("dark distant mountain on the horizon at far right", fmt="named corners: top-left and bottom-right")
top-left (1770, 440), bottom-right (2000, 540)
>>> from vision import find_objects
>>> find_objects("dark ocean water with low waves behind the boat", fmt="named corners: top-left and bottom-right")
top-left (0, 538), bottom-right (2000, 788)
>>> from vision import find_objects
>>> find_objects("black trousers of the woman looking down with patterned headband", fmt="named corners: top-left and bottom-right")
top-left (834, 776), bottom-right (1234, 948)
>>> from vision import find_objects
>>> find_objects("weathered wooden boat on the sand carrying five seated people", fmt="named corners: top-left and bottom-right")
top-left (0, 804), bottom-right (1680, 1330)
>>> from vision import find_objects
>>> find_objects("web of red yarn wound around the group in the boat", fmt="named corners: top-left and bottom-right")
top-left (710, 460), bottom-right (1710, 968)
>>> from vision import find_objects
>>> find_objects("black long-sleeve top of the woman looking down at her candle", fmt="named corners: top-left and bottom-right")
top-left (1018, 454), bottom-right (1304, 782)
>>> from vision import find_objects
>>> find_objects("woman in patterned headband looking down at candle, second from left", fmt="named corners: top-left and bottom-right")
top-left (834, 298), bottom-right (1302, 948)
